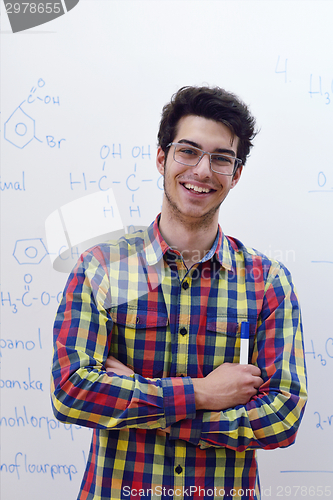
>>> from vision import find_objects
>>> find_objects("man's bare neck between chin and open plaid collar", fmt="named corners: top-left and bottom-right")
top-left (159, 210), bottom-right (218, 268)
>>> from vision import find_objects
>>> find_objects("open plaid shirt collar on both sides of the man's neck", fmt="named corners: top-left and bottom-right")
top-left (144, 214), bottom-right (232, 271)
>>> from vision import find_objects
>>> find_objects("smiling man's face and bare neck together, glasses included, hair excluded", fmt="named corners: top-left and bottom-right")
top-left (157, 115), bottom-right (243, 264)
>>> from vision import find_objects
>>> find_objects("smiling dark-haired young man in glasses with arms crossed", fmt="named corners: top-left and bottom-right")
top-left (52, 87), bottom-right (307, 500)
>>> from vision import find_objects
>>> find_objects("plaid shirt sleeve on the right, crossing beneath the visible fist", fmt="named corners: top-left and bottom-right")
top-left (170, 267), bottom-right (307, 452)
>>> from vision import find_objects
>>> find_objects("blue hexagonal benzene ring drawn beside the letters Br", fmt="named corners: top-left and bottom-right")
top-left (4, 105), bottom-right (35, 149)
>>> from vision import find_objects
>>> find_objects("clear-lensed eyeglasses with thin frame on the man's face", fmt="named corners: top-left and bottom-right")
top-left (167, 142), bottom-right (242, 175)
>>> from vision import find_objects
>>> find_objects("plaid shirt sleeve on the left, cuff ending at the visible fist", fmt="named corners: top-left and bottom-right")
top-left (51, 247), bottom-right (196, 429)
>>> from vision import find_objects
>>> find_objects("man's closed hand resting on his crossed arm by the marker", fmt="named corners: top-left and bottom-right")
top-left (192, 363), bottom-right (264, 411)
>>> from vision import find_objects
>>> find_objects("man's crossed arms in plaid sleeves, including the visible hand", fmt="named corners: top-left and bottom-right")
top-left (52, 252), bottom-right (306, 451)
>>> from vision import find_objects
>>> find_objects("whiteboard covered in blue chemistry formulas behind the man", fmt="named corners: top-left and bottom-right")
top-left (0, 0), bottom-right (333, 500)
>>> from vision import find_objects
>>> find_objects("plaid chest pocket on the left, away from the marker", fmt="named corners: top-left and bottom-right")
top-left (110, 309), bottom-right (171, 378)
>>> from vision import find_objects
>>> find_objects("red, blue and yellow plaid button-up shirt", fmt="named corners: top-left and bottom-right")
top-left (52, 218), bottom-right (307, 500)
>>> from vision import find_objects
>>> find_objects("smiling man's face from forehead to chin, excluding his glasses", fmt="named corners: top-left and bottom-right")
top-left (157, 115), bottom-right (242, 224)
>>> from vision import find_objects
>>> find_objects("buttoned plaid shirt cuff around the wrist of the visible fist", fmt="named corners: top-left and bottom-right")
top-left (161, 377), bottom-right (196, 427)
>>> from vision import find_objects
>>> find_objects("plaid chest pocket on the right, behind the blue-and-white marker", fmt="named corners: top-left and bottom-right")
top-left (204, 315), bottom-right (256, 375)
